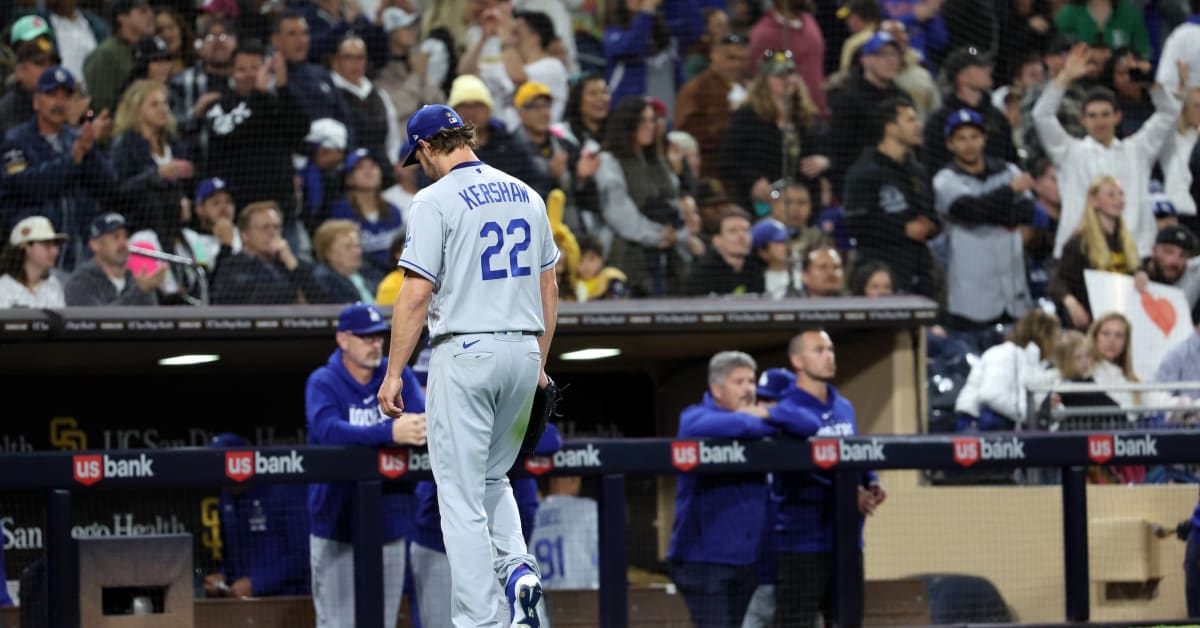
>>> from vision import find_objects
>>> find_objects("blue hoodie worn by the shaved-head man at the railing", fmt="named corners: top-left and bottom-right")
top-left (768, 385), bottom-right (877, 554)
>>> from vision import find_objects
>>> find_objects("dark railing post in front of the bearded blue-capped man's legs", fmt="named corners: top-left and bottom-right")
top-left (354, 480), bottom-right (381, 628)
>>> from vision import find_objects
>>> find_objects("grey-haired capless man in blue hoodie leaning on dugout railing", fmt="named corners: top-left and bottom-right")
top-left (667, 351), bottom-right (775, 628)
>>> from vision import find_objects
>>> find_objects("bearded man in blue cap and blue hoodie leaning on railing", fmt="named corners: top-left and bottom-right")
top-left (305, 303), bottom-right (425, 627)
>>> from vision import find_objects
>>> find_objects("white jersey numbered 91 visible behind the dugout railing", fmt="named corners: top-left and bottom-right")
top-left (529, 495), bottom-right (600, 590)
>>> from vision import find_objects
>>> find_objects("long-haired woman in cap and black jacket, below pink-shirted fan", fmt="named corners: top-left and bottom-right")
top-left (716, 50), bottom-right (829, 217)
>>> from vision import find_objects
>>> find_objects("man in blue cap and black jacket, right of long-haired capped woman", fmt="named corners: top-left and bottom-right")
top-left (829, 31), bottom-right (905, 192)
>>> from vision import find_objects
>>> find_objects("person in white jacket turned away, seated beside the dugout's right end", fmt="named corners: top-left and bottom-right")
top-left (954, 309), bottom-right (1060, 431)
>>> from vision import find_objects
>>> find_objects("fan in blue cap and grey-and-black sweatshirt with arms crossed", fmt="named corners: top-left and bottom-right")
top-left (934, 108), bottom-right (1034, 352)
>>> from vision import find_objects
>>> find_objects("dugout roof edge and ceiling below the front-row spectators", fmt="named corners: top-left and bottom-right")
top-left (0, 297), bottom-right (936, 375)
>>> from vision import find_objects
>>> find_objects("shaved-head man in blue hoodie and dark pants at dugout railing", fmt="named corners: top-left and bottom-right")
top-left (770, 329), bottom-right (887, 627)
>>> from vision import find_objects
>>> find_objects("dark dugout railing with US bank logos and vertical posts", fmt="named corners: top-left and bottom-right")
top-left (0, 430), bottom-right (1200, 628)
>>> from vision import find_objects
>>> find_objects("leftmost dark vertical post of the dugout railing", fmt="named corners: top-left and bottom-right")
top-left (46, 490), bottom-right (79, 628)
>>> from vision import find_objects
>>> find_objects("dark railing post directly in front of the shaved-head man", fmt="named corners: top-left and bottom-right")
top-left (833, 471), bottom-right (863, 626)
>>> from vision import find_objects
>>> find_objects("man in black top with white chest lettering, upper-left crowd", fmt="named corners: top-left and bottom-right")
top-left (205, 41), bottom-right (308, 225)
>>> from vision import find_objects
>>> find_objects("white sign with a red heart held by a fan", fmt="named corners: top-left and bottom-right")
top-left (1084, 270), bottom-right (1195, 382)
